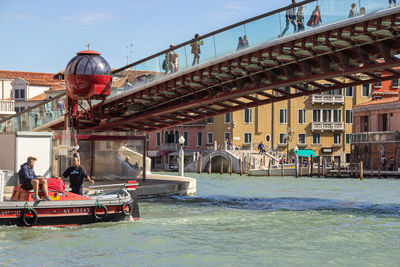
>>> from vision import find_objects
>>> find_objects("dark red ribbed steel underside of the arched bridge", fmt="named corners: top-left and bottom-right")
top-left (55, 11), bottom-right (400, 132)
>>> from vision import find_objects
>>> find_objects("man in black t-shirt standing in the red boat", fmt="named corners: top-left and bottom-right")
top-left (63, 156), bottom-right (94, 195)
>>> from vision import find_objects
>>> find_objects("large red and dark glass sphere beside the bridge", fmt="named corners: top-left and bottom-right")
top-left (65, 50), bottom-right (112, 99)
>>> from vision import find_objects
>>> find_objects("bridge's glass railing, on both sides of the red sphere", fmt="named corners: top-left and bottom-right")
top-left (0, 0), bottom-right (389, 131)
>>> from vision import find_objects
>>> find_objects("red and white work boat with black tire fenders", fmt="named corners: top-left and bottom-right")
top-left (0, 179), bottom-right (140, 227)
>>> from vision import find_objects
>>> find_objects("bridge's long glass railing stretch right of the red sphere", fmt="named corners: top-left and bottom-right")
top-left (114, 0), bottom-right (388, 95)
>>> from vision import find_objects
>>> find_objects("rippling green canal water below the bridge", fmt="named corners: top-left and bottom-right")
top-left (0, 173), bottom-right (400, 266)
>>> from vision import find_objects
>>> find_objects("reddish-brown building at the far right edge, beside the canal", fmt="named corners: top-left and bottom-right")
top-left (351, 97), bottom-right (400, 170)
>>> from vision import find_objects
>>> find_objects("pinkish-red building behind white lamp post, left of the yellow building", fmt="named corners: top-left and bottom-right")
top-left (146, 121), bottom-right (206, 169)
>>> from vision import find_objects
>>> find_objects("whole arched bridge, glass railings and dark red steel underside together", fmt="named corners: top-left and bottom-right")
top-left (0, 0), bottom-right (400, 132)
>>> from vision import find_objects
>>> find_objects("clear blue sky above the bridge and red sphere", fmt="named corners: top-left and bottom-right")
top-left (0, 0), bottom-right (291, 73)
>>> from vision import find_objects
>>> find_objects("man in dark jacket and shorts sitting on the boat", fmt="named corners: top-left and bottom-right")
top-left (18, 157), bottom-right (51, 201)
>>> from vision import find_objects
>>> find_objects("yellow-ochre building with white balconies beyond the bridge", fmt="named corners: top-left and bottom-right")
top-left (206, 84), bottom-right (372, 163)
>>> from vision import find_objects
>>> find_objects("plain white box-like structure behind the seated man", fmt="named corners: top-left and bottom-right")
top-left (0, 132), bottom-right (53, 182)
